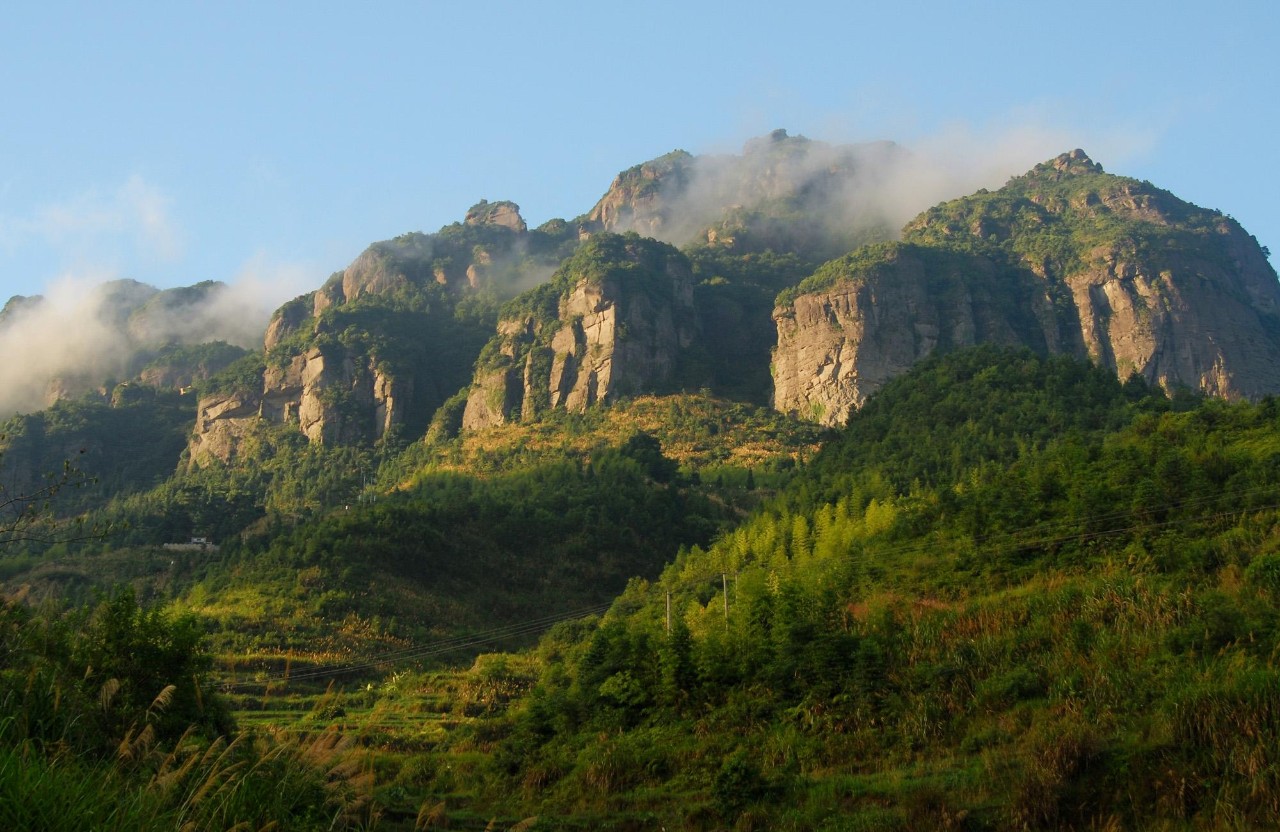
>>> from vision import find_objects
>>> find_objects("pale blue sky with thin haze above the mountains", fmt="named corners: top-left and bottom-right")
top-left (0, 0), bottom-right (1280, 305)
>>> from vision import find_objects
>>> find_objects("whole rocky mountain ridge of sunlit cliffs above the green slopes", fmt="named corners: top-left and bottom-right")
top-left (0, 131), bottom-right (1280, 501)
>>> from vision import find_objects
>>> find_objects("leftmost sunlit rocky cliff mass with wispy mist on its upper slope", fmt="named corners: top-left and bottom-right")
top-left (189, 201), bottom-right (572, 465)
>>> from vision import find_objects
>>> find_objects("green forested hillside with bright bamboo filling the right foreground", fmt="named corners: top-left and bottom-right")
top-left (422, 349), bottom-right (1280, 829)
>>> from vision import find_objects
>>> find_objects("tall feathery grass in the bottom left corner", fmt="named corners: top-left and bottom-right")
top-left (0, 696), bottom-right (376, 832)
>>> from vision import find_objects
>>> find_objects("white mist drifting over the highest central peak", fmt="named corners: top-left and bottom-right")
top-left (589, 119), bottom-right (1148, 253)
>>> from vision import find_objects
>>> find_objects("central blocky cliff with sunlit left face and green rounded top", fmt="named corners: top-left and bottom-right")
top-left (462, 234), bottom-right (698, 430)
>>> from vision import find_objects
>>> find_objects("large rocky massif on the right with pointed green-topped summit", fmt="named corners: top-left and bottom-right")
top-left (774, 151), bottom-right (1280, 425)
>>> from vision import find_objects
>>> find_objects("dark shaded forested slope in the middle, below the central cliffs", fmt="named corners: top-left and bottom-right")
top-left (178, 434), bottom-right (730, 659)
